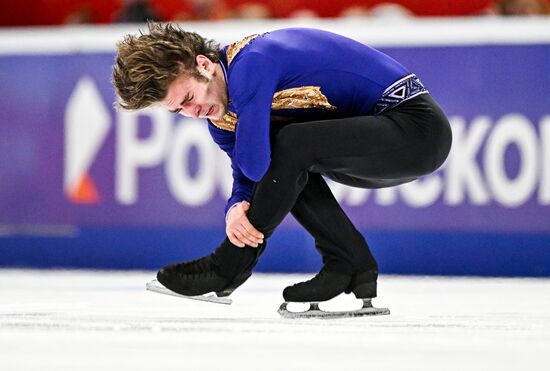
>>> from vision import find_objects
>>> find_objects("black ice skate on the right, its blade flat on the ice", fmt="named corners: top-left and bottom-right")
top-left (278, 268), bottom-right (390, 318)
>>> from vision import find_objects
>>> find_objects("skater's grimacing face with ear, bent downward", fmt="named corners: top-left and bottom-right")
top-left (161, 55), bottom-right (228, 119)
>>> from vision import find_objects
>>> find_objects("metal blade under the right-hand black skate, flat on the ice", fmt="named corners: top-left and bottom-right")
top-left (277, 299), bottom-right (390, 319)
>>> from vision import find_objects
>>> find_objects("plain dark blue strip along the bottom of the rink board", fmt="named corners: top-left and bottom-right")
top-left (0, 228), bottom-right (550, 276)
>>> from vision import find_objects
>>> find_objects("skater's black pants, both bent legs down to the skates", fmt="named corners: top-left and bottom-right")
top-left (214, 94), bottom-right (451, 278)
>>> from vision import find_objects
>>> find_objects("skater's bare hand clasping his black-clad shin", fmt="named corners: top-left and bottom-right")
top-left (225, 201), bottom-right (264, 247)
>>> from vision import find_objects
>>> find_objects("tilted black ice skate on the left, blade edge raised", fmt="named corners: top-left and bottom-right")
top-left (146, 255), bottom-right (251, 304)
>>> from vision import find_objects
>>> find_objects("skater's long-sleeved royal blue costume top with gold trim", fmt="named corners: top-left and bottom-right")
top-left (208, 28), bottom-right (409, 212)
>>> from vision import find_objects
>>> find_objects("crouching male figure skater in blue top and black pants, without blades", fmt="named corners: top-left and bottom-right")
top-left (113, 23), bottom-right (451, 308)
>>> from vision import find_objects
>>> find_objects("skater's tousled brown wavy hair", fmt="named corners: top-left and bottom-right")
top-left (112, 22), bottom-right (220, 110)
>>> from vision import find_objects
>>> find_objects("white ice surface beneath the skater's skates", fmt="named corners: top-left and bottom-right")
top-left (0, 270), bottom-right (550, 371)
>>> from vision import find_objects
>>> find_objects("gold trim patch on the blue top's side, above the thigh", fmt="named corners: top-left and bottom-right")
top-left (271, 86), bottom-right (336, 111)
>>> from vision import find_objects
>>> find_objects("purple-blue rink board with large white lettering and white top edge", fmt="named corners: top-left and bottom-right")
top-left (0, 21), bottom-right (550, 276)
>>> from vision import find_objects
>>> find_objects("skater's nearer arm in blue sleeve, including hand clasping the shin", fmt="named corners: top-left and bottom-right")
top-left (212, 53), bottom-right (280, 247)
